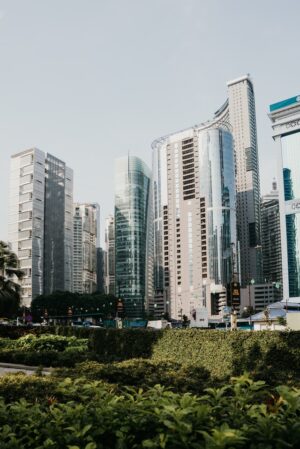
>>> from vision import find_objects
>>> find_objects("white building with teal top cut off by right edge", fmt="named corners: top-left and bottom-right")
top-left (269, 96), bottom-right (300, 299)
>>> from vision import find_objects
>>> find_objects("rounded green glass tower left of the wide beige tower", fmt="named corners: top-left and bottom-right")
top-left (115, 156), bottom-right (153, 318)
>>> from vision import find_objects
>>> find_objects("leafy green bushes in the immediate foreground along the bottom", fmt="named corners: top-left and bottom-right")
top-left (0, 375), bottom-right (300, 449)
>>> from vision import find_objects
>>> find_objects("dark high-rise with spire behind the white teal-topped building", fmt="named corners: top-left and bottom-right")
top-left (261, 181), bottom-right (282, 287)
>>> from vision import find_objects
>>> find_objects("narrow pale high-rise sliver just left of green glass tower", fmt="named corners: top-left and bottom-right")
top-left (104, 215), bottom-right (118, 295)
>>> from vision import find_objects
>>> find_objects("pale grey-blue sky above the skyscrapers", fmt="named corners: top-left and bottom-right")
top-left (0, 0), bottom-right (300, 242)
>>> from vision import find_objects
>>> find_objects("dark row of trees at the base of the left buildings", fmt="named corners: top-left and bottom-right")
top-left (31, 291), bottom-right (117, 321)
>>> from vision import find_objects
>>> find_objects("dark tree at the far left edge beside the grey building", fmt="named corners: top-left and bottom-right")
top-left (0, 240), bottom-right (24, 318)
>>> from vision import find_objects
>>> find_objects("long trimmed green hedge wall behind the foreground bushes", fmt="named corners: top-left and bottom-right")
top-left (0, 326), bottom-right (300, 383)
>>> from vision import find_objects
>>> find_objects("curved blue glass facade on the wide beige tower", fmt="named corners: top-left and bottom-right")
top-left (198, 128), bottom-right (236, 286)
